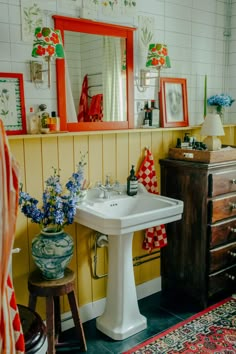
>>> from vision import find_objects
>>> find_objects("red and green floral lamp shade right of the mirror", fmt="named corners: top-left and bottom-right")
top-left (146, 43), bottom-right (171, 68)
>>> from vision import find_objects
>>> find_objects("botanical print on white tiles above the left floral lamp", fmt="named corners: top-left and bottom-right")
top-left (21, 0), bottom-right (43, 42)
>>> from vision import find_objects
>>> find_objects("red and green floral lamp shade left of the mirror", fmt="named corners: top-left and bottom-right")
top-left (32, 27), bottom-right (65, 58)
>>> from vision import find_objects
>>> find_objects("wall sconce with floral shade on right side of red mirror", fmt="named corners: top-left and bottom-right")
top-left (137, 43), bottom-right (171, 92)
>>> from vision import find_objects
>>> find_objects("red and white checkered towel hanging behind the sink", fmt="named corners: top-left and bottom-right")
top-left (137, 149), bottom-right (167, 252)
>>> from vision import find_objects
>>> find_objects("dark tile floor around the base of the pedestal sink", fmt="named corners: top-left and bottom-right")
top-left (57, 292), bottom-right (206, 354)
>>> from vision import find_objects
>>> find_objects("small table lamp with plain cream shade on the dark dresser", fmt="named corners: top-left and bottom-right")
top-left (200, 113), bottom-right (225, 151)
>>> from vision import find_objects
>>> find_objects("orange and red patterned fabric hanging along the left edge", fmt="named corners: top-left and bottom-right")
top-left (0, 119), bottom-right (25, 354)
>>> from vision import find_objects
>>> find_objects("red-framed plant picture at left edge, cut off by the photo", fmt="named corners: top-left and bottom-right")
top-left (0, 73), bottom-right (26, 135)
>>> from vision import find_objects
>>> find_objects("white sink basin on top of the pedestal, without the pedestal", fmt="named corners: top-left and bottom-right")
top-left (75, 185), bottom-right (183, 235)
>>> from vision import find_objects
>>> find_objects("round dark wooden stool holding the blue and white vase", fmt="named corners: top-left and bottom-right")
top-left (28, 268), bottom-right (87, 354)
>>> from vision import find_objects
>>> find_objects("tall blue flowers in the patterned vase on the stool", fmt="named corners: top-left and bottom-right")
top-left (19, 156), bottom-right (86, 232)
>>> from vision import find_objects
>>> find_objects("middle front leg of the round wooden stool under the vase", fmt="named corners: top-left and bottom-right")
top-left (46, 296), bottom-right (56, 354)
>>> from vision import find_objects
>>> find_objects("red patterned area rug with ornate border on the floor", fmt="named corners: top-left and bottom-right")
top-left (123, 298), bottom-right (236, 354)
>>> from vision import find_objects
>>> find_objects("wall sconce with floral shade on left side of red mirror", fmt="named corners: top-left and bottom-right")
top-left (30, 27), bottom-right (65, 87)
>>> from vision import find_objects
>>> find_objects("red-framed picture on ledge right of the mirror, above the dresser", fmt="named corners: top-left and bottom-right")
top-left (159, 77), bottom-right (188, 128)
